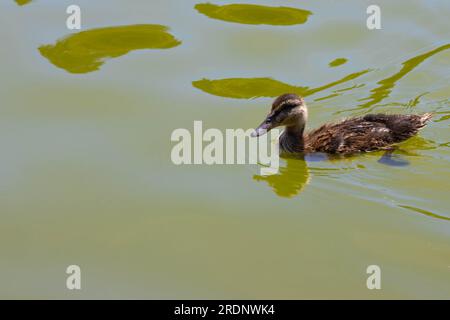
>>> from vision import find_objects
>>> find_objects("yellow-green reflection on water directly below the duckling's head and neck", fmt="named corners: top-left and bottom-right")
top-left (253, 158), bottom-right (309, 198)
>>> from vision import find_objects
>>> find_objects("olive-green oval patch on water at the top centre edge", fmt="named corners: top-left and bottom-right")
top-left (195, 3), bottom-right (312, 26)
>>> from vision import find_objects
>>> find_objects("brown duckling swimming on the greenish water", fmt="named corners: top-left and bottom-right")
top-left (252, 94), bottom-right (432, 154)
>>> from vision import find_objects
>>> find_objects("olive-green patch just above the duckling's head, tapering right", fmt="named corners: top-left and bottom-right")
top-left (192, 69), bottom-right (371, 99)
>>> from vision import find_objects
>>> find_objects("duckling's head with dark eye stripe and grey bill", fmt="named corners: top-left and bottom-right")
top-left (252, 93), bottom-right (308, 137)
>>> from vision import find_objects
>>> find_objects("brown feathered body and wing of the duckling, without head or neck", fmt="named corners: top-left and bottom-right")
top-left (305, 114), bottom-right (431, 153)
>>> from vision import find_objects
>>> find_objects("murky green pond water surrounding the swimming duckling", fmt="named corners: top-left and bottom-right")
top-left (0, 0), bottom-right (450, 299)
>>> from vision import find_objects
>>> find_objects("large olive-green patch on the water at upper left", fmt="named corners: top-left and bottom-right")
top-left (39, 24), bottom-right (181, 73)
